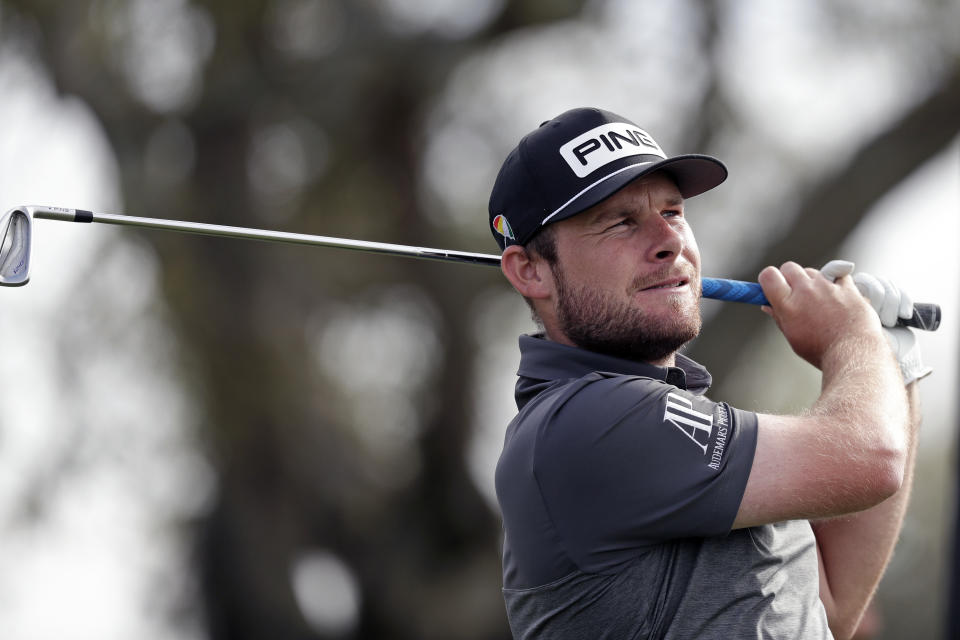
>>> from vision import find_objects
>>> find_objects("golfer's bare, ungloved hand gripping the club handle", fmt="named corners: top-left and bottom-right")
top-left (759, 261), bottom-right (880, 369)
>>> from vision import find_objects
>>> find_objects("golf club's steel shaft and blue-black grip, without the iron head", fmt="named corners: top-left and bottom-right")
top-left (24, 206), bottom-right (940, 331)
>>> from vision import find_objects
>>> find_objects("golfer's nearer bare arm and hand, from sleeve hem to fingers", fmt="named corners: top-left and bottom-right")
top-left (734, 263), bottom-right (909, 528)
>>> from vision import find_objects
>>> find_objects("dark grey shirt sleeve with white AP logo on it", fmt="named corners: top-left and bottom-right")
top-left (534, 373), bottom-right (757, 571)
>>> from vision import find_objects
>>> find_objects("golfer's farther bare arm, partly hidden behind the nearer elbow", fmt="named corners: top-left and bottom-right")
top-left (811, 382), bottom-right (921, 638)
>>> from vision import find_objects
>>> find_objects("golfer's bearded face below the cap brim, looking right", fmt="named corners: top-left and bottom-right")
top-left (552, 173), bottom-right (701, 364)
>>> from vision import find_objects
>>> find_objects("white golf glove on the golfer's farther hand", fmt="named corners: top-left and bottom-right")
top-left (820, 260), bottom-right (933, 384)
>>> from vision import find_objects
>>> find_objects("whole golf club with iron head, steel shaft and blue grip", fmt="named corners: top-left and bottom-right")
top-left (0, 206), bottom-right (940, 331)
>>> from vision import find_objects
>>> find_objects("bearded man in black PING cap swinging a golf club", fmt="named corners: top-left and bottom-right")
top-left (490, 109), bottom-right (929, 638)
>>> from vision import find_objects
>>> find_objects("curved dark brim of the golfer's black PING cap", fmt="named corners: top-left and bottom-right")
top-left (544, 154), bottom-right (727, 224)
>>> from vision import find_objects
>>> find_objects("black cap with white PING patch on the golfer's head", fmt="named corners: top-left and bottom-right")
top-left (489, 108), bottom-right (727, 250)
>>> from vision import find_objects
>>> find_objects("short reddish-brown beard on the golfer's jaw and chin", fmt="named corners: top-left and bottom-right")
top-left (554, 269), bottom-right (702, 363)
